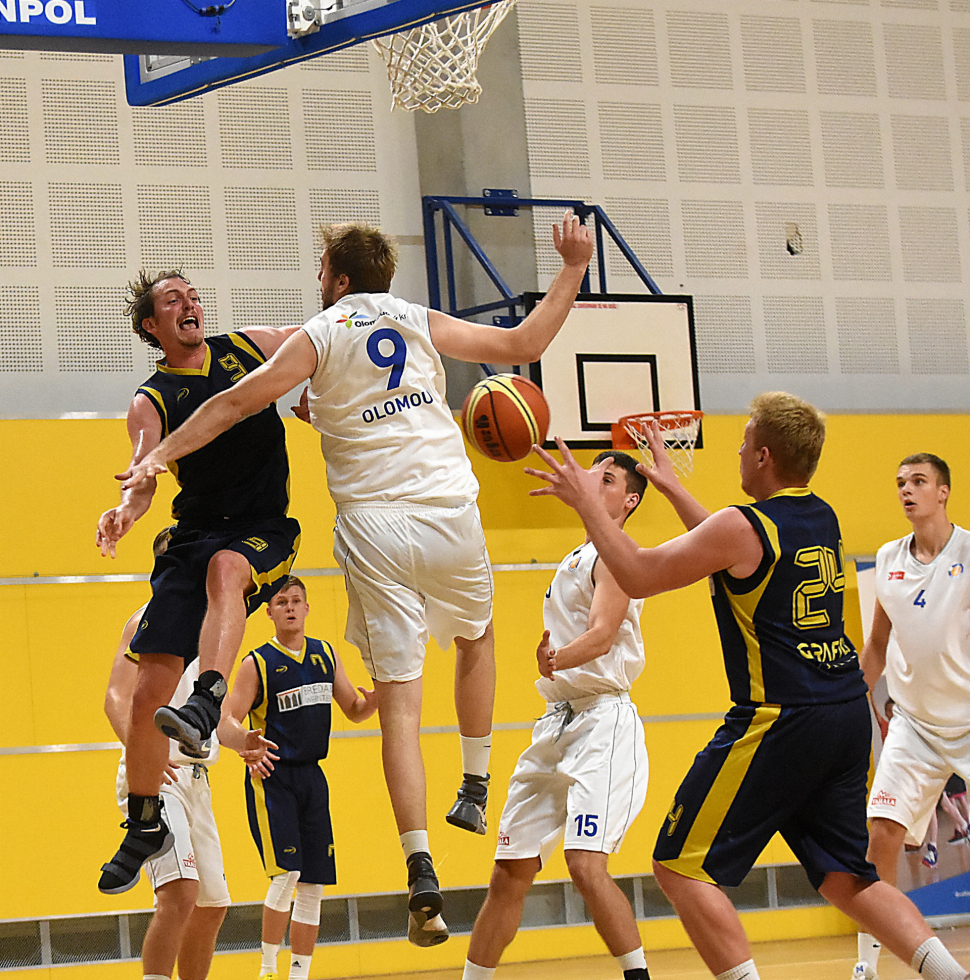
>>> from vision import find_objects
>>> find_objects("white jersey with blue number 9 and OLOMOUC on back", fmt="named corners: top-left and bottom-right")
top-left (303, 293), bottom-right (478, 510)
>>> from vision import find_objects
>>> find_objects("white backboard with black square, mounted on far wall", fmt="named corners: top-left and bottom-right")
top-left (524, 293), bottom-right (701, 449)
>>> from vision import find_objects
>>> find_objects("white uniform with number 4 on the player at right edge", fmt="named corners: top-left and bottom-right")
top-left (868, 526), bottom-right (970, 844)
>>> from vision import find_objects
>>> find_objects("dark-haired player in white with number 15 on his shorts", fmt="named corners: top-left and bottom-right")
top-left (463, 452), bottom-right (649, 980)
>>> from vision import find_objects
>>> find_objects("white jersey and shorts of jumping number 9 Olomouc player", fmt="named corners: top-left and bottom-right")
top-left (303, 293), bottom-right (492, 681)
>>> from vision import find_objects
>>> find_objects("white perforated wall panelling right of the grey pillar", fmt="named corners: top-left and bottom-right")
top-left (519, 0), bottom-right (970, 411)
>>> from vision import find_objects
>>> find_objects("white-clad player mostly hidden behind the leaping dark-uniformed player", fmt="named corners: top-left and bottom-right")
top-left (104, 529), bottom-right (230, 980)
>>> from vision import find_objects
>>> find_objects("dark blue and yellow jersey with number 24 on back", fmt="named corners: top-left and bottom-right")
top-left (713, 487), bottom-right (866, 705)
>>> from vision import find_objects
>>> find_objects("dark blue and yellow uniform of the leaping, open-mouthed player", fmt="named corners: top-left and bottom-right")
top-left (131, 333), bottom-right (300, 663)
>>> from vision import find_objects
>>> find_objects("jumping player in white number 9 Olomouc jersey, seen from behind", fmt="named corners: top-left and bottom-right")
top-left (122, 214), bottom-right (593, 936)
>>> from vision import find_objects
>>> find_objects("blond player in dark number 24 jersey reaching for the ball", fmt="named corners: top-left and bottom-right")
top-left (528, 392), bottom-right (968, 980)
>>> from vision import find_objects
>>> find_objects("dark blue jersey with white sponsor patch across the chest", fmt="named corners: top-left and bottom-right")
top-left (248, 637), bottom-right (335, 763)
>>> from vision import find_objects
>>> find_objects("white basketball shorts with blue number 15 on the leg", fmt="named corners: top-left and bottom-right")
top-left (495, 692), bottom-right (649, 864)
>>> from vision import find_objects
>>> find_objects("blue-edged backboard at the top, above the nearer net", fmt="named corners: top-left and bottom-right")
top-left (122, 0), bottom-right (496, 106)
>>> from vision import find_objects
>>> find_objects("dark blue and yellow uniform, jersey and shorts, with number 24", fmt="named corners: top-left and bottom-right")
top-left (654, 488), bottom-right (877, 888)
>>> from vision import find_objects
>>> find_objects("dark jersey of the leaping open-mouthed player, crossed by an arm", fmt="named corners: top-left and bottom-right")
top-left (138, 333), bottom-right (290, 528)
